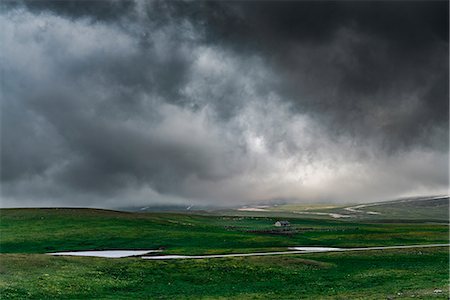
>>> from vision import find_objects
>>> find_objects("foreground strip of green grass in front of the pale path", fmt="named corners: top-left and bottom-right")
top-left (0, 248), bottom-right (448, 299)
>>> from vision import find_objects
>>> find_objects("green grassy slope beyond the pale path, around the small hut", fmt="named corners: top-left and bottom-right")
top-left (0, 209), bottom-right (448, 254)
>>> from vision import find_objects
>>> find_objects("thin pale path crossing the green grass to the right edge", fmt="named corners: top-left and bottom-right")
top-left (142, 244), bottom-right (450, 259)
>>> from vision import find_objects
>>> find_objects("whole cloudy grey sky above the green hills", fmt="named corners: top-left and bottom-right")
top-left (0, 0), bottom-right (449, 208)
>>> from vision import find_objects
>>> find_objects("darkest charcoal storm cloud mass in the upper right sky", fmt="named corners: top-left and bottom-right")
top-left (201, 1), bottom-right (448, 150)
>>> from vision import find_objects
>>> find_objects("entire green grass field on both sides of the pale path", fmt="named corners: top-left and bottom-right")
top-left (0, 209), bottom-right (449, 299)
